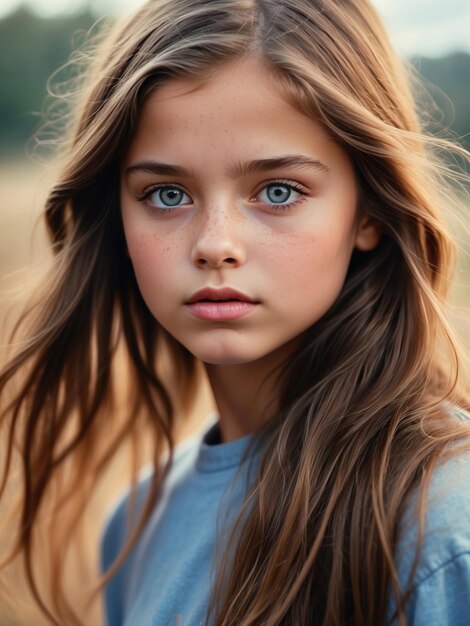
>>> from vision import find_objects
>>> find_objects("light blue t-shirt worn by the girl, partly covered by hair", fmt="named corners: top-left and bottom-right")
top-left (101, 412), bottom-right (470, 626)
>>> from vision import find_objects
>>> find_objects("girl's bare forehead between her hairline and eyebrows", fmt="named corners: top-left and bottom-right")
top-left (126, 60), bottom-right (345, 178)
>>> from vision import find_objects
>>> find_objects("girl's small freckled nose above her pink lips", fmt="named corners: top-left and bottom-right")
top-left (191, 212), bottom-right (246, 268)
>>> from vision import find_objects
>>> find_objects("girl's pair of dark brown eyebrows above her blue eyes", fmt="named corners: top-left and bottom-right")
top-left (126, 154), bottom-right (330, 178)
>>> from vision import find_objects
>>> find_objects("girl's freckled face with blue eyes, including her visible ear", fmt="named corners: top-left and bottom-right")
top-left (121, 61), bottom-right (378, 364)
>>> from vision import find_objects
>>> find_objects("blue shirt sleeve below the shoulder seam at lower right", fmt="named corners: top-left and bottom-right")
top-left (408, 552), bottom-right (470, 626)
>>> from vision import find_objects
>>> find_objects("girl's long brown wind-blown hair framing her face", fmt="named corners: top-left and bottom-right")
top-left (0, 0), bottom-right (469, 626)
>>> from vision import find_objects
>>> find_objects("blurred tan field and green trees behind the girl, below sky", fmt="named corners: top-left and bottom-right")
top-left (0, 7), bottom-right (470, 626)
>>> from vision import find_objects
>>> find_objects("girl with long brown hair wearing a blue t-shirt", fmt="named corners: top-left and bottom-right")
top-left (1, 0), bottom-right (470, 626)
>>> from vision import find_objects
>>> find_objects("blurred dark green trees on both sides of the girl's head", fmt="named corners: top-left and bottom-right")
top-left (0, 7), bottom-right (470, 159)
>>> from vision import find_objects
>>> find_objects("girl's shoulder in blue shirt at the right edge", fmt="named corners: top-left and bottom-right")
top-left (398, 410), bottom-right (470, 626)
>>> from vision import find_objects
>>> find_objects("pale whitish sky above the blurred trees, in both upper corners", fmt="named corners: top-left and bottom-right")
top-left (0, 0), bottom-right (470, 57)
